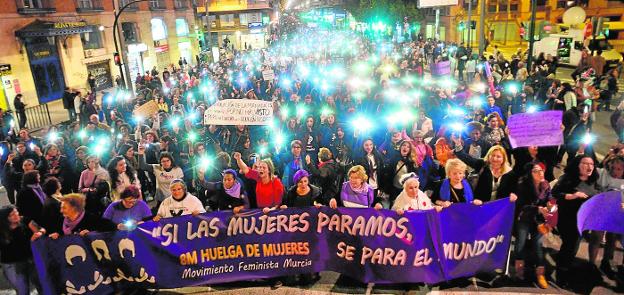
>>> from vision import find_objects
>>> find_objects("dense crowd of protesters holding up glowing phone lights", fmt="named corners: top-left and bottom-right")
top-left (0, 24), bottom-right (624, 294)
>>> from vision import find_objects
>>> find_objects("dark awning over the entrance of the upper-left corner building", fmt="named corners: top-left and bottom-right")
top-left (15, 20), bottom-right (95, 38)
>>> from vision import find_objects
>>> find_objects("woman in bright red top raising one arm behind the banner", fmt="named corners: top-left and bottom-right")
top-left (233, 152), bottom-right (284, 213)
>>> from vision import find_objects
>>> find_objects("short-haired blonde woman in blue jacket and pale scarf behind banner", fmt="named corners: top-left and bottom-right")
top-left (435, 159), bottom-right (483, 208)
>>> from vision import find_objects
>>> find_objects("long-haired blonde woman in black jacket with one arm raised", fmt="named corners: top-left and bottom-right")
top-left (454, 139), bottom-right (518, 202)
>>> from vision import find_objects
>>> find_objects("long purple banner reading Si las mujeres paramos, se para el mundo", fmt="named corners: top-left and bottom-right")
top-left (32, 199), bottom-right (514, 294)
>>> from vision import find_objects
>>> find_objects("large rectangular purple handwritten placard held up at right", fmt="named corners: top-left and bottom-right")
top-left (507, 111), bottom-right (563, 148)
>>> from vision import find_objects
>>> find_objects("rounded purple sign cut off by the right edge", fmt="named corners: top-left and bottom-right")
top-left (576, 191), bottom-right (624, 234)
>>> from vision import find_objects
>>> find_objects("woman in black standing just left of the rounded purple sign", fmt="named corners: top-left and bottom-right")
top-left (552, 154), bottom-right (600, 286)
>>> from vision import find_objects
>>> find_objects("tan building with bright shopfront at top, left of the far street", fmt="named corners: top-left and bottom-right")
top-left (197, 0), bottom-right (276, 50)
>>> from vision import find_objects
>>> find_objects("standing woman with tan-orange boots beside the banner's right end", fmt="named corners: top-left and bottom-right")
top-left (511, 162), bottom-right (556, 289)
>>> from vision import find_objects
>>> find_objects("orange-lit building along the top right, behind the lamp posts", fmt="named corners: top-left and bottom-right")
top-left (421, 0), bottom-right (624, 51)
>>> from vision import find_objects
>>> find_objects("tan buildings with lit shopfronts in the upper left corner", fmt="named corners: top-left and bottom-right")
top-left (0, 0), bottom-right (199, 109)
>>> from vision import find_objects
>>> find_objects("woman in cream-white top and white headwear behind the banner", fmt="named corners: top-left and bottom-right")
top-left (392, 172), bottom-right (442, 215)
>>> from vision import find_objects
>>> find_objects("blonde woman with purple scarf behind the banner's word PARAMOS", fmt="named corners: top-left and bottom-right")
top-left (329, 165), bottom-right (383, 210)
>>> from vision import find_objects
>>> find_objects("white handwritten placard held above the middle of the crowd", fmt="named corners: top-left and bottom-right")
top-left (204, 99), bottom-right (273, 125)
